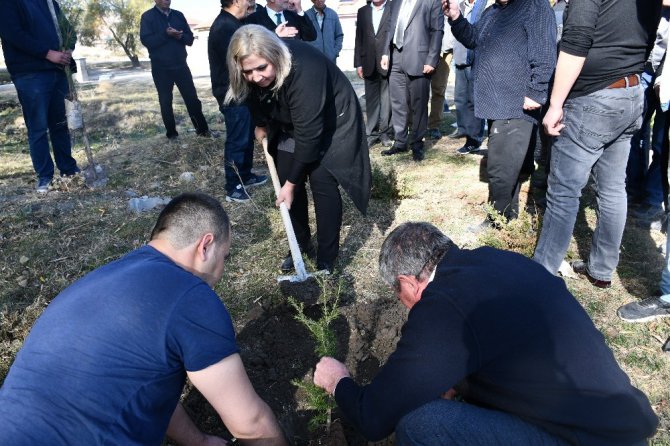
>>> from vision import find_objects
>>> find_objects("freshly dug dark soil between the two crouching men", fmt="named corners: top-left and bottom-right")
top-left (185, 288), bottom-right (407, 445)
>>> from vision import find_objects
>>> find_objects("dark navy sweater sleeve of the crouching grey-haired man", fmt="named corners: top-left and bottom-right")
top-left (335, 288), bottom-right (478, 441)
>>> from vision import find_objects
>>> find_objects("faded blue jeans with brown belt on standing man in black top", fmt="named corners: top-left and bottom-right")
top-left (533, 85), bottom-right (644, 280)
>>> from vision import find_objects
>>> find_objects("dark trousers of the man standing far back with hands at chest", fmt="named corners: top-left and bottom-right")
top-left (151, 65), bottom-right (209, 138)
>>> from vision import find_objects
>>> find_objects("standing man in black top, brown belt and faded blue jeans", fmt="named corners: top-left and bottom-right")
top-left (534, 0), bottom-right (661, 288)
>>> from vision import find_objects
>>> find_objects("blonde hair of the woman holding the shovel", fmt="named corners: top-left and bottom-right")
top-left (224, 25), bottom-right (291, 105)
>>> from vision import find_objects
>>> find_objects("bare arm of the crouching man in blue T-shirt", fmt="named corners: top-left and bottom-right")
top-left (186, 353), bottom-right (287, 446)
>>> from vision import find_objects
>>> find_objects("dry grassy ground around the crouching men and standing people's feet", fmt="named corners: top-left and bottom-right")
top-left (0, 77), bottom-right (670, 445)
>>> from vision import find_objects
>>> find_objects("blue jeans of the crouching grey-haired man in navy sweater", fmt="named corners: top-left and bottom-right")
top-left (395, 400), bottom-right (568, 446)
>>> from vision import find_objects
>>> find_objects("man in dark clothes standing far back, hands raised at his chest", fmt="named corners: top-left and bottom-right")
top-left (140, 0), bottom-right (210, 139)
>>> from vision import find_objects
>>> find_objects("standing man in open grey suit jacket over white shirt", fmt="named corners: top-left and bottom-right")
top-left (382, 0), bottom-right (444, 161)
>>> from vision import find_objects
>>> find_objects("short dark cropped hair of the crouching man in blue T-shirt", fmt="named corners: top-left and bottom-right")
top-left (151, 192), bottom-right (230, 249)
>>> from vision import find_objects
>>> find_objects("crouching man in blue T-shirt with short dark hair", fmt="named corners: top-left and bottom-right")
top-left (0, 193), bottom-right (286, 446)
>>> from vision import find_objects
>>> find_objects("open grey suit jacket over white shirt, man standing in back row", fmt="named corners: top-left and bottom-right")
top-left (387, 0), bottom-right (444, 76)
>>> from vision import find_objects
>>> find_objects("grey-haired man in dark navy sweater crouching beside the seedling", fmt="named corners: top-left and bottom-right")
top-left (314, 223), bottom-right (658, 446)
